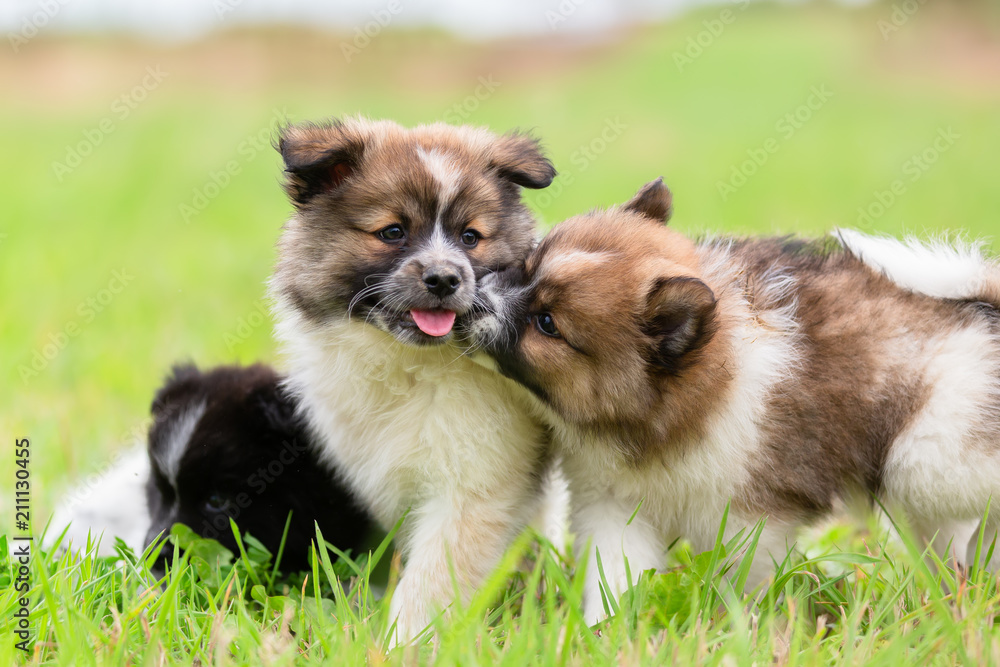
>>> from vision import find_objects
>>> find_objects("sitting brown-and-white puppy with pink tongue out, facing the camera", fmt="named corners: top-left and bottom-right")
top-left (271, 118), bottom-right (555, 642)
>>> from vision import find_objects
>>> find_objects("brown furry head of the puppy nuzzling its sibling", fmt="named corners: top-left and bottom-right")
top-left (494, 189), bottom-right (725, 460)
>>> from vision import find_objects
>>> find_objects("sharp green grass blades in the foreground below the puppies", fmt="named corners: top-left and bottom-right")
top-left (0, 512), bottom-right (1000, 666)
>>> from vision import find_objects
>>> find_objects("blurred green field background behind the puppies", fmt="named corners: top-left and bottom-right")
top-left (0, 0), bottom-right (1000, 529)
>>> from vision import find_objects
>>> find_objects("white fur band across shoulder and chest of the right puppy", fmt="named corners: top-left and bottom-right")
top-left (554, 300), bottom-right (798, 548)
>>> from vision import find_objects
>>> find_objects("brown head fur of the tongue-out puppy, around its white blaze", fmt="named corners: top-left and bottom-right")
top-left (275, 118), bottom-right (555, 334)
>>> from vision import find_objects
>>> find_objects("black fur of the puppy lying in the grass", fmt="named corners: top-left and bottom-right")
top-left (147, 365), bottom-right (372, 571)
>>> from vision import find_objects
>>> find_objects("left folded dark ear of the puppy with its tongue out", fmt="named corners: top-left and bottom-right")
top-left (277, 121), bottom-right (366, 206)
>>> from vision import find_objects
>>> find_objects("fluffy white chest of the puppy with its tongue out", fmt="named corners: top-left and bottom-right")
top-left (278, 309), bottom-right (540, 526)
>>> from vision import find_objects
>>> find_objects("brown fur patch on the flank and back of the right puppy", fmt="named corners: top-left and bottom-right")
top-left (712, 239), bottom-right (936, 515)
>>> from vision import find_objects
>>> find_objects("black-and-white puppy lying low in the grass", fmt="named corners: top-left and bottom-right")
top-left (49, 365), bottom-right (372, 572)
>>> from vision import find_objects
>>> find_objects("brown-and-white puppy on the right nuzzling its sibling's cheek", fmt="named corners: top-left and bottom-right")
top-left (476, 180), bottom-right (1000, 621)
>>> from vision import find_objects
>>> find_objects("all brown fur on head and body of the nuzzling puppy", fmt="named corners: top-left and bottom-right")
top-left (480, 182), bottom-right (1000, 517)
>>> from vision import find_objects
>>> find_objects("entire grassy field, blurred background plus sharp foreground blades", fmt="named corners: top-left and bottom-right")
top-left (0, 3), bottom-right (1000, 664)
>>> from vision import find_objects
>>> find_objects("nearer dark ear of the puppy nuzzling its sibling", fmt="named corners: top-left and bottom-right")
top-left (644, 277), bottom-right (716, 373)
